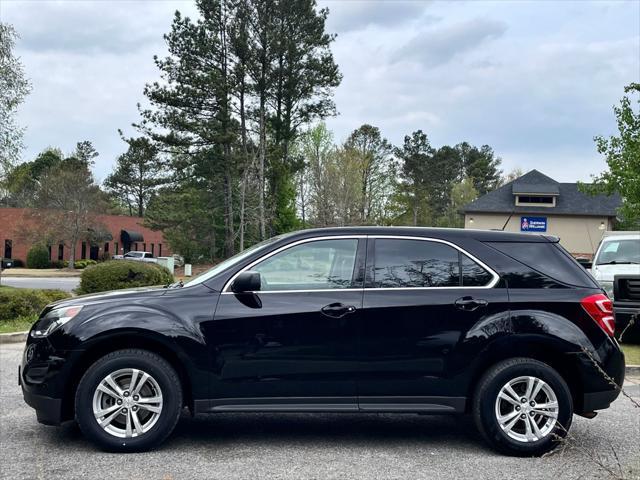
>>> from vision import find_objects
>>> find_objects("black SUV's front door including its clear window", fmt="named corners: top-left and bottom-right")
top-left (205, 237), bottom-right (365, 411)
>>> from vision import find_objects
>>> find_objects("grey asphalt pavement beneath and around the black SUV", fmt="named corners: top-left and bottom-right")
top-left (0, 344), bottom-right (640, 480)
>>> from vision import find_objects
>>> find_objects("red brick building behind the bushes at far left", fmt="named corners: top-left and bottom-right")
top-left (0, 208), bottom-right (173, 262)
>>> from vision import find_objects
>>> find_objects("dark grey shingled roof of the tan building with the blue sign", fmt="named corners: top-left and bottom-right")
top-left (461, 170), bottom-right (622, 217)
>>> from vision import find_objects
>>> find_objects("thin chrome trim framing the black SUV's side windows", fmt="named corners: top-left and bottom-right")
top-left (222, 234), bottom-right (500, 295)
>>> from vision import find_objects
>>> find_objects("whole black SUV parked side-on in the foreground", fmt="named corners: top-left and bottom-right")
top-left (19, 227), bottom-right (624, 455)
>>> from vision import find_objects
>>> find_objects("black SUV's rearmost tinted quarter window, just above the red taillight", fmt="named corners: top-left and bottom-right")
top-left (487, 242), bottom-right (597, 288)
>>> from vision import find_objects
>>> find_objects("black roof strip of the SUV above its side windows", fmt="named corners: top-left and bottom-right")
top-left (282, 226), bottom-right (559, 243)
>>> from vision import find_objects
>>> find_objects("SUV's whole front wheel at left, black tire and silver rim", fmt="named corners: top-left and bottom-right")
top-left (75, 349), bottom-right (182, 452)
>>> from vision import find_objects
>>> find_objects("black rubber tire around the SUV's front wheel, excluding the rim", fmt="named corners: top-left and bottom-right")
top-left (75, 349), bottom-right (182, 452)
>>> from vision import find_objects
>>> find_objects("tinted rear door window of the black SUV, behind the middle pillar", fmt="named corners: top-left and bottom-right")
top-left (373, 239), bottom-right (460, 288)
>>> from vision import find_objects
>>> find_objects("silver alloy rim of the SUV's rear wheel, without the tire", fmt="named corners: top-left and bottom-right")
top-left (495, 376), bottom-right (559, 443)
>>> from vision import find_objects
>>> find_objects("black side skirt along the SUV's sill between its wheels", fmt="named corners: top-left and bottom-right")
top-left (194, 397), bottom-right (467, 414)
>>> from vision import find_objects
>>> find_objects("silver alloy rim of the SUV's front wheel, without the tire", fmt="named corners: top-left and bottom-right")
top-left (93, 368), bottom-right (163, 438)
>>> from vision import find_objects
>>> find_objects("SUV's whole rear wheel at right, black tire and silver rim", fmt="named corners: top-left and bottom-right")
top-left (473, 358), bottom-right (573, 456)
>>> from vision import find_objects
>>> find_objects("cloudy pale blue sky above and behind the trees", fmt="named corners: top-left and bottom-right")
top-left (0, 0), bottom-right (640, 181)
